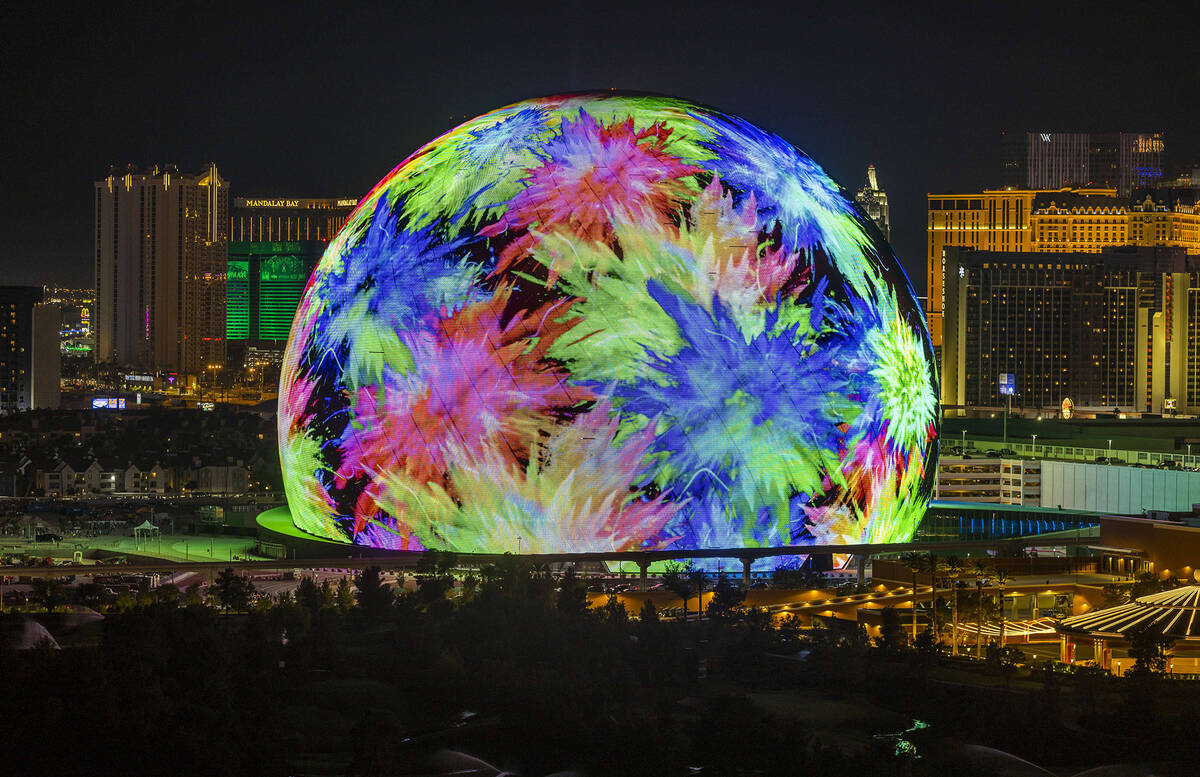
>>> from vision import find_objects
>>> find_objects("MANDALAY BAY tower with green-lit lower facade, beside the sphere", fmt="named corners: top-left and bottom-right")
top-left (226, 197), bottom-right (358, 369)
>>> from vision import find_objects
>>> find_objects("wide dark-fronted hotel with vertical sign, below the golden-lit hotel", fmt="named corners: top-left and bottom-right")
top-left (942, 247), bottom-right (1200, 412)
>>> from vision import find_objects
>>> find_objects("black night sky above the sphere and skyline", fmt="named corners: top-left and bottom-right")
top-left (0, 0), bottom-right (1200, 293)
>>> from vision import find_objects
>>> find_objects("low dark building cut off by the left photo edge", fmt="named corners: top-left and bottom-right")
top-left (0, 287), bottom-right (61, 415)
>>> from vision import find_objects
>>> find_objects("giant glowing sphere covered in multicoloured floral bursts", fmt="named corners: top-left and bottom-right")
top-left (280, 94), bottom-right (940, 553)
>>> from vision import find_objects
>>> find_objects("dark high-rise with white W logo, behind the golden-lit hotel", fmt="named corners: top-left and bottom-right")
top-left (1001, 132), bottom-right (1165, 195)
